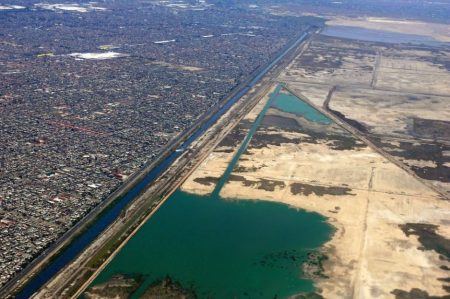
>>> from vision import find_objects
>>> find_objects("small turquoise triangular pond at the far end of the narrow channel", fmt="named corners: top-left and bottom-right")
top-left (272, 93), bottom-right (331, 125)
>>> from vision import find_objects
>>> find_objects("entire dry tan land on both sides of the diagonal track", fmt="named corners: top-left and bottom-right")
top-left (182, 37), bottom-right (450, 298)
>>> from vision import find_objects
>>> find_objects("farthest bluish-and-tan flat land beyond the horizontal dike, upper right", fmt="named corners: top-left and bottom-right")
top-left (280, 37), bottom-right (450, 96)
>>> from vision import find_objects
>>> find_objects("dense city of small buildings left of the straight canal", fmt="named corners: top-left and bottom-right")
top-left (0, 1), bottom-right (316, 286)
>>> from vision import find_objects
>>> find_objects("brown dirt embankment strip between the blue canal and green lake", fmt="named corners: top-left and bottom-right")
top-left (39, 29), bottom-right (314, 298)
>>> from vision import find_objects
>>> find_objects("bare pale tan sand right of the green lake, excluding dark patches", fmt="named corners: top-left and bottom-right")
top-left (218, 145), bottom-right (450, 298)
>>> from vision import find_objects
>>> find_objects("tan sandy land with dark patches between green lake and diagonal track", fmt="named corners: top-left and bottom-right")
top-left (182, 81), bottom-right (450, 298)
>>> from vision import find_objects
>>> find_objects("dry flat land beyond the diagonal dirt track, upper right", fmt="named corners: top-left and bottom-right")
top-left (281, 36), bottom-right (450, 197)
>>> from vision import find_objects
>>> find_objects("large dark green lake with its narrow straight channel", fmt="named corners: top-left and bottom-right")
top-left (86, 85), bottom-right (332, 299)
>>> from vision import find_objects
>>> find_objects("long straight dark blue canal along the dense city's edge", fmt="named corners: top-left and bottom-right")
top-left (0, 28), bottom-right (316, 298)
